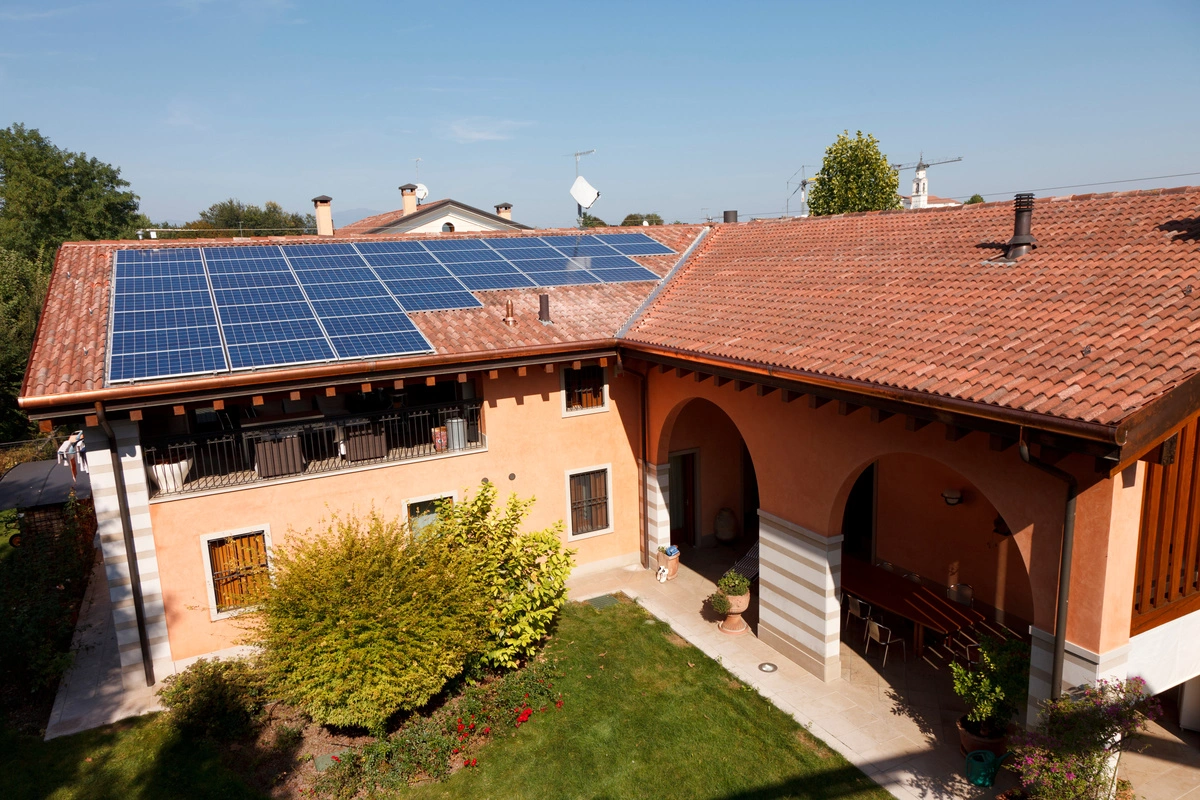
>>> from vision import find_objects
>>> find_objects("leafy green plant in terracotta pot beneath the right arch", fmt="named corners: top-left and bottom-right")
top-left (950, 636), bottom-right (1030, 757)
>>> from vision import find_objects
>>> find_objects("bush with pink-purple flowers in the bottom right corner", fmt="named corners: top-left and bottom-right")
top-left (1012, 678), bottom-right (1160, 800)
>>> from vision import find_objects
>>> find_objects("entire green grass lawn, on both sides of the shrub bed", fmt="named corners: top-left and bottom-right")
top-left (0, 602), bottom-right (890, 800)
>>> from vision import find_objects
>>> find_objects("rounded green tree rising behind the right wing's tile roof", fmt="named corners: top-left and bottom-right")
top-left (809, 131), bottom-right (900, 216)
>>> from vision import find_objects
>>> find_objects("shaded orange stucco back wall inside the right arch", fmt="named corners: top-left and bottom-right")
top-left (875, 453), bottom-right (1033, 624)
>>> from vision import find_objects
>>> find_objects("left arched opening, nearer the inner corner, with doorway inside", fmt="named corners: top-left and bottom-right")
top-left (667, 399), bottom-right (758, 566)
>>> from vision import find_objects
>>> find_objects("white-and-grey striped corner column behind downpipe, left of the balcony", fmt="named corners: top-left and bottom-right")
top-left (84, 420), bottom-right (174, 688)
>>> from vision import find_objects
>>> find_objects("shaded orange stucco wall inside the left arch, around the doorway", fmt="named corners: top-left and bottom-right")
top-left (662, 402), bottom-right (742, 545)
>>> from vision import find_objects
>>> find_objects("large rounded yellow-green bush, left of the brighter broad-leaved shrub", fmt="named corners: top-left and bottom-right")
top-left (260, 512), bottom-right (488, 733)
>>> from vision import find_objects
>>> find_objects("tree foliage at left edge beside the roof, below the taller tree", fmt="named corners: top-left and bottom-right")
top-left (0, 248), bottom-right (49, 441)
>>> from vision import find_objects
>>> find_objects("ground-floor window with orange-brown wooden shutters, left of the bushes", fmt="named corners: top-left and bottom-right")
top-left (200, 529), bottom-right (271, 620)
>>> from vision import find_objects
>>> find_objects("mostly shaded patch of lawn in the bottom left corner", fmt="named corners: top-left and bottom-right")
top-left (0, 716), bottom-right (259, 800)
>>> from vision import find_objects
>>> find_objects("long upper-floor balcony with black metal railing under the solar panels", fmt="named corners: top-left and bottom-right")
top-left (143, 401), bottom-right (487, 498)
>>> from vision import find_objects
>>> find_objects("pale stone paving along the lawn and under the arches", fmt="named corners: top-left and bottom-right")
top-left (569, 551), bottom-right (1200, 800)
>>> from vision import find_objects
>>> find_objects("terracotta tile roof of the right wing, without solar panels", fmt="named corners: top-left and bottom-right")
top-left (625, 187), bottom-right (1200, 425)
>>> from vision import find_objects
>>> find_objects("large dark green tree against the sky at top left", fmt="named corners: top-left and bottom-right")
top-left (0, 124), bottom-right (138, 261)
